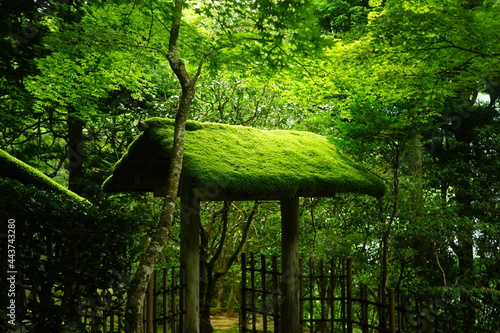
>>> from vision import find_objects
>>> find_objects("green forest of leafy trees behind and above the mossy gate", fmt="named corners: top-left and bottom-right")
top-left (0, 0), bottom-right (500, 330)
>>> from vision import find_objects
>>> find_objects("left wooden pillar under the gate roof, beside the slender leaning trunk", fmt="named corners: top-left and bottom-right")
top-left (180, 190), bottom-right (201, 333)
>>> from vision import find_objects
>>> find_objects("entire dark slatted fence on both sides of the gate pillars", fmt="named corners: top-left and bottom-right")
top-left (13, 254), bottom-right (500, 333)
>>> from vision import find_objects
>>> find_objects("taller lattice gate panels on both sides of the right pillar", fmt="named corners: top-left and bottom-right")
top-left (240, 253), bottom-right (354, 332)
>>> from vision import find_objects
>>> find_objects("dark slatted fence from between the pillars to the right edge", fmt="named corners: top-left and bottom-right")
top-left (240, 254), bottom-right (500, 333)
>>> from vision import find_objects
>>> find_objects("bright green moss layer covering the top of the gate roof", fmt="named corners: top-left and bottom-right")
top-left (105, 118), bottom-right (385, 196)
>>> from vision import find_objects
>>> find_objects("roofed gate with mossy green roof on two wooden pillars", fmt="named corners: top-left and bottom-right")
top-left (103, 118), bottom-right (386, 333)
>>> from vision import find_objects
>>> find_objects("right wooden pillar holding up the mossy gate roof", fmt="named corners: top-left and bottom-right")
top-left (281, 198), bottom-right (301, 333)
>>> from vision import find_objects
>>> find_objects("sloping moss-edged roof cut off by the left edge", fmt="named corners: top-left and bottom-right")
top-left (0, 149), bottom-right (87, 201)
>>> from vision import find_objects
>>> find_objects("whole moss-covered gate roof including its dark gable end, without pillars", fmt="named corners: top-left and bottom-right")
top-left (103, 118), bottom-right (385, 200)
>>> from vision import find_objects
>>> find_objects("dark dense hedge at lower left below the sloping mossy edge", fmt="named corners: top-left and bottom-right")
top-left (0, 178), bottom-right (144, 332)
